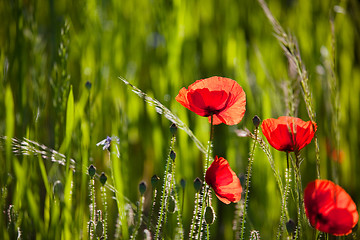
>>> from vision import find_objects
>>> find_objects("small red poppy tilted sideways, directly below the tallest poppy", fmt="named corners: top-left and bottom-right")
top-left (205, 156), bottom-right (242, 204)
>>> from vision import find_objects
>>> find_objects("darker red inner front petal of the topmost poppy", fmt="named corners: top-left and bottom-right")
top-left (187, 88), bottom-right (231, 116)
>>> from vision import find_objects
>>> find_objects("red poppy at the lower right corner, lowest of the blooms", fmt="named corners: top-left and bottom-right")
top-left (304, 180), bottom-right (359, 235)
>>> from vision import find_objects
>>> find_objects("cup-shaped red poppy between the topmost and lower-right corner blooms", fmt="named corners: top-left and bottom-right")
top-left (261, 116), bottom-right (317, 152)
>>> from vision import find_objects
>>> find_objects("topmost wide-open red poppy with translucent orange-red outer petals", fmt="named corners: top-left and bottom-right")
top-left (175, 77), bottom-right (246, 125)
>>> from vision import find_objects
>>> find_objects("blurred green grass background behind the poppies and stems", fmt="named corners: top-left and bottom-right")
top-left (0, 0), bottom-right (360, 239)
